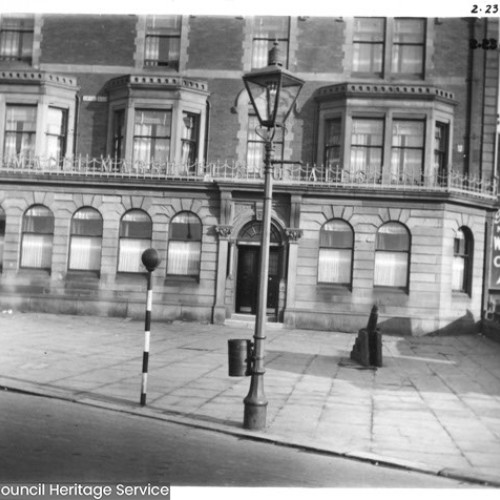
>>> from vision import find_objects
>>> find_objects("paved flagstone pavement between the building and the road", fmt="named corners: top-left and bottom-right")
top-left (0, 311), bottom-right (500, 487)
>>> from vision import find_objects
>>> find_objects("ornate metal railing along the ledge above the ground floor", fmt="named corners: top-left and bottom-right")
top-left (0, 156), bottom-right (498, 199)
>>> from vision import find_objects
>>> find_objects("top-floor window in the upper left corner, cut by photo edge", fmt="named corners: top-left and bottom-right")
top-left (0, 15), bottom-right (34, 63)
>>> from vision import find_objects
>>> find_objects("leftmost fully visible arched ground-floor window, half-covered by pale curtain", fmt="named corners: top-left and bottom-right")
top-left (21, 205), bottom-right (54, 270)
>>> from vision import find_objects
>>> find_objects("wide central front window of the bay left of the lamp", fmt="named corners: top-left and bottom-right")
top-left (134, 109), bottom-right (172, 164)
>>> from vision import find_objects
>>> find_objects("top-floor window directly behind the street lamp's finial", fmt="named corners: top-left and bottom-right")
top-left (252, 16), bottom-right (290, 69)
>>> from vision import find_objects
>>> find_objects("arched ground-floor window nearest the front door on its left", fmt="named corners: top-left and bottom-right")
top-left (167, 212), bottom-right (202, 276)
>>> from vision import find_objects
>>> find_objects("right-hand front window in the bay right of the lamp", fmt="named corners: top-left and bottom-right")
top-left (391, 120), bottom-right (425, 184)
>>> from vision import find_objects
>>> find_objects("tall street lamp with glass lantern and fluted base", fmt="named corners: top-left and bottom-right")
top-left (243, 42), bottom-right (304, 430)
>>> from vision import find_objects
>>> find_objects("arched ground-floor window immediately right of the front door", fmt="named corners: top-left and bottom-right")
top-left (318, 219), bottom-right (354, 285)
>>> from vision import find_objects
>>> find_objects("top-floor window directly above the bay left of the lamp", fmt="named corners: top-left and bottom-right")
top-left (144, 16), bottom-right (182, 70)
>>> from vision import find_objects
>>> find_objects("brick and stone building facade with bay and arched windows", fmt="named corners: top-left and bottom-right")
top-left (0, 14), bottom-right (499, 335)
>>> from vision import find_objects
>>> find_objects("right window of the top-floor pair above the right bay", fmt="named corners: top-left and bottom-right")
top-left (392, 19), bottom-right (426, 77)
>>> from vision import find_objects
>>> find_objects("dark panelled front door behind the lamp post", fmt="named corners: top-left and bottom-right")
top-left (236, 245), bottom-right (281, 317)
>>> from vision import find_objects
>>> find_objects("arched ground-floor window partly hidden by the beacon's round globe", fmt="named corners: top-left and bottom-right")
top-left (118, 209), bottom-right (153, 273)
